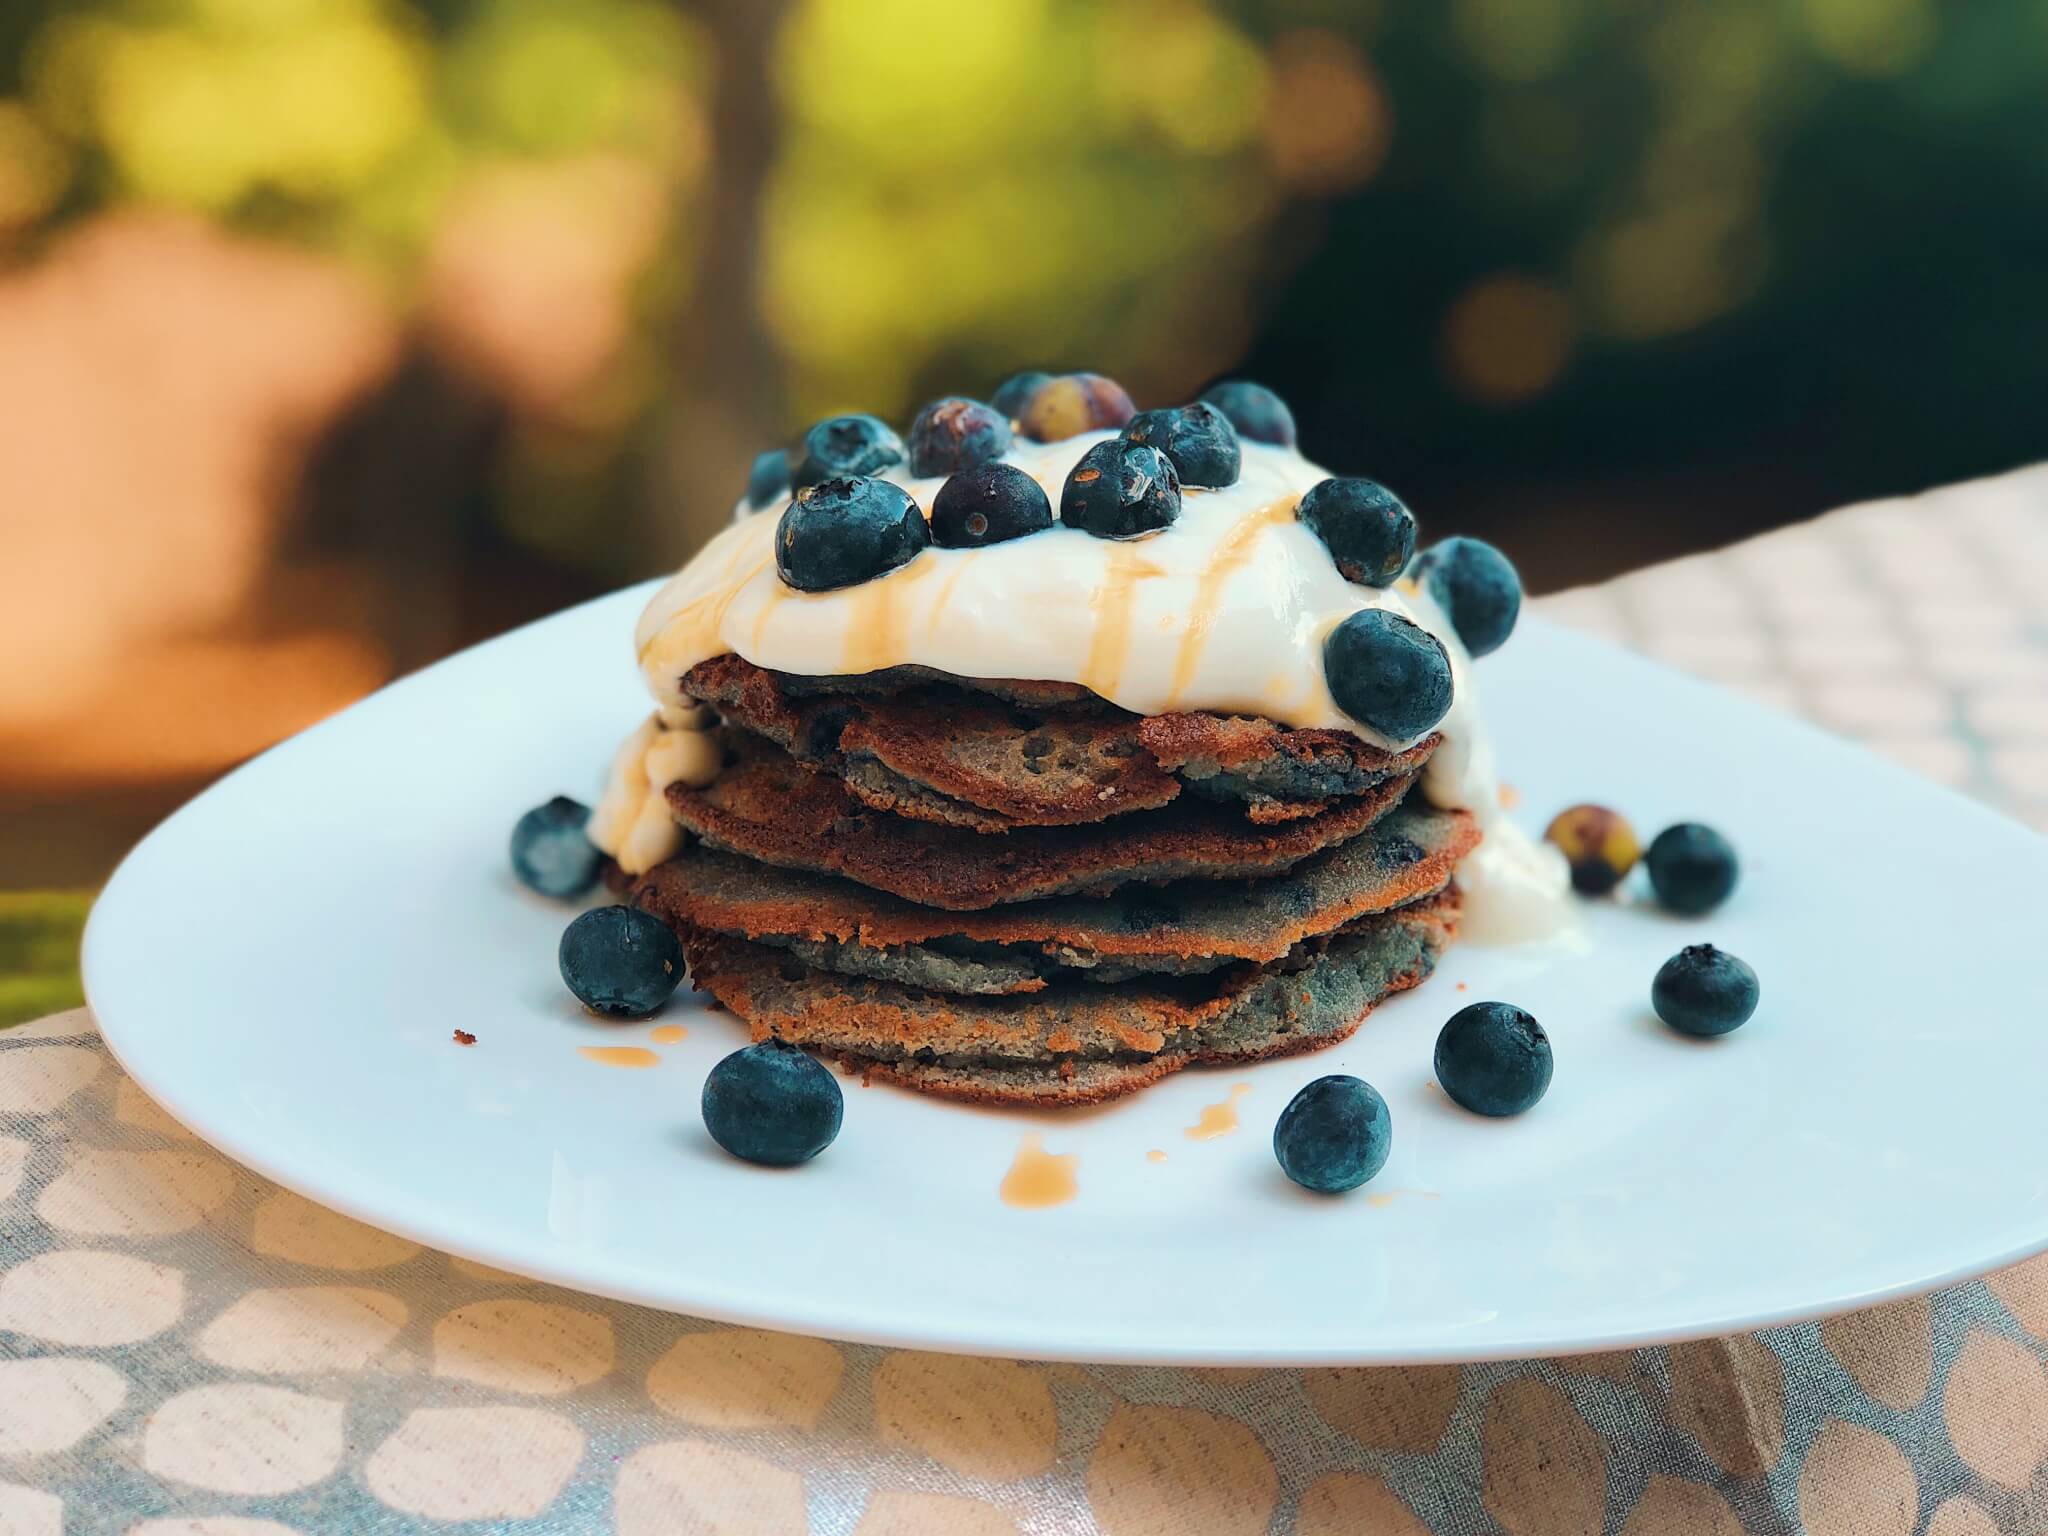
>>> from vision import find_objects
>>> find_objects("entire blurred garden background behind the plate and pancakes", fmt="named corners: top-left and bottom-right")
top-left (0, 0), bottom-right (2048, 1011)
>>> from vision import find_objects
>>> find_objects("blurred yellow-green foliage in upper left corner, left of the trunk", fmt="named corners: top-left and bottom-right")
top-left (0, 0), bottom-right (705, 259)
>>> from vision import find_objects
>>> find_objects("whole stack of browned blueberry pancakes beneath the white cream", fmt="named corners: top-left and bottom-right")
top-left (633, 655), bottom-right (1479, 1104)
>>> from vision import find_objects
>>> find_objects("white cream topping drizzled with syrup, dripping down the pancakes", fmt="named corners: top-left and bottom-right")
top-left (590, 432), bottom-right (1569, 942)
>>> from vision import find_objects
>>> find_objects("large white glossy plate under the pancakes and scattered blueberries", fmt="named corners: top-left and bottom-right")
top-left (86, 590), bottom-right (2048, 1364)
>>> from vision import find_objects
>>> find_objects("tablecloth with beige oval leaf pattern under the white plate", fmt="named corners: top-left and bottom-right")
top-left (0, 469), bottom-right (2048, 1536)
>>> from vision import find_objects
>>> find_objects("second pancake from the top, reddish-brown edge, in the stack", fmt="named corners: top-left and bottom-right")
top-left (668, 733), bottom-right (1413, 911)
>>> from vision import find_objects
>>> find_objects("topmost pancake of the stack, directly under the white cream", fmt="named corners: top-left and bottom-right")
top-left (682, 655), bottom-right (1438, 831)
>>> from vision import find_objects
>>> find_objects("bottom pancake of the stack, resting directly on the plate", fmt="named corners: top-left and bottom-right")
top-left (686, 889), bottom-right (1458, 1106)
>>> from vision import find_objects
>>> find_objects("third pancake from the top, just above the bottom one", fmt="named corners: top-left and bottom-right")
top-left (633, 795), bottom-right (1479, 995)
